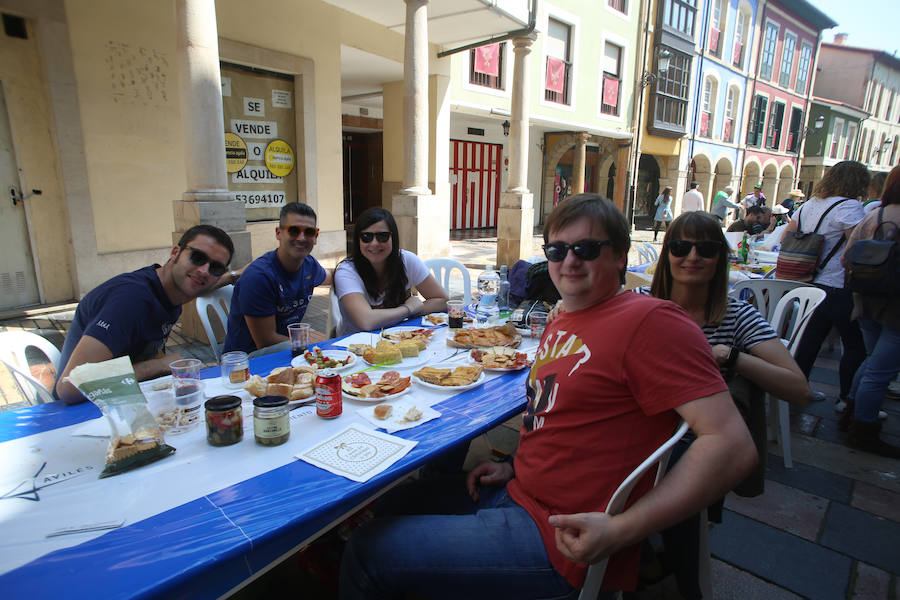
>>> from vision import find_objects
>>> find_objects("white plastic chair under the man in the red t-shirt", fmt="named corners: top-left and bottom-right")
top-left (578, 421), bottom-right (712, 600)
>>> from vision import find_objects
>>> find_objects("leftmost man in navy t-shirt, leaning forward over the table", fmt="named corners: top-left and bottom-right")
top-left (53, 225), bottom-right (234, 404)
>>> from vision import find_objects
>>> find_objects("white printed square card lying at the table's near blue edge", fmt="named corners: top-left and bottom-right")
top-left (295, 425), bottom-right (418, 483)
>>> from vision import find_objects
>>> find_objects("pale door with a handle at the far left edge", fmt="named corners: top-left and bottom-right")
top-left (0, 82), bottom-right (39, 310)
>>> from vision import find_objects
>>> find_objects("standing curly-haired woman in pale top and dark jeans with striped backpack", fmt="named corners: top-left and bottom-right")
top-left (785, 160), bottom-right (869, 406)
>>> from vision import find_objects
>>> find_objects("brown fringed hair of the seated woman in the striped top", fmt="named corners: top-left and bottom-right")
top-left (650, 211), bottom-right (729, 324)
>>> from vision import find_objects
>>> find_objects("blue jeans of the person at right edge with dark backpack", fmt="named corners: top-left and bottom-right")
top-left (850, 318), bottom-right (900, 423)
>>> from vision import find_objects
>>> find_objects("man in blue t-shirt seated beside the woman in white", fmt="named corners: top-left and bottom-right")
top-left (222, 202), bottom-right (332, 353)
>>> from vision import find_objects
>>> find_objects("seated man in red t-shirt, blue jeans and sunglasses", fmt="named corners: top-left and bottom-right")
top-left (341, 194), bottom-right (756, 598)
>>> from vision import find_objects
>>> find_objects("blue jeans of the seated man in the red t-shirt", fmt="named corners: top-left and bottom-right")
top-left (340, 478), bottom-right (577, 600)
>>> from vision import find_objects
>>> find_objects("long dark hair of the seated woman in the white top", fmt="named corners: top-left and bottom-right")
top-left (344, 206), bottom-right (409, 308)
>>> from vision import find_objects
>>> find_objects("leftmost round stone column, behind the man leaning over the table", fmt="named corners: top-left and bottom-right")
top-left (172, 0), bottom-right (253, 340)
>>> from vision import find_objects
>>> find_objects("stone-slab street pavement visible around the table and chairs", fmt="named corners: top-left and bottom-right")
top-left (0, 230), bottom-right (900, 600)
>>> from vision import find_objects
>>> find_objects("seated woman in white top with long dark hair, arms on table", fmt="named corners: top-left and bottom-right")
top-left (334, 207), bottom-right (447, 335)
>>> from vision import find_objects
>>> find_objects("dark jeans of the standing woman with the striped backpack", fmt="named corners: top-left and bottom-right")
top-left (794, 285), bottom-right (866, 398)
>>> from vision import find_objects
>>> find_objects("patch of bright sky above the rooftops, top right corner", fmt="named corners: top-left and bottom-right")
top-left (810, 0), bottom-right (900, 54)
